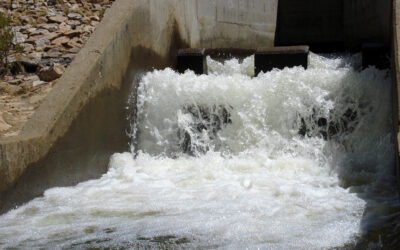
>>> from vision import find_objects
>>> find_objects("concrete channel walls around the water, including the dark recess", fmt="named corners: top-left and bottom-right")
top-left (0, 0), bottom-right (400, 217)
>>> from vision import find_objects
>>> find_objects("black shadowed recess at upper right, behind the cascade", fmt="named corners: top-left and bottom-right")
top-left (275, 0), bottom-right (392, 48)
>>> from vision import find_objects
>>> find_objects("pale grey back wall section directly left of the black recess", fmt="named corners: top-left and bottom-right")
top-left (197, 0), bottom-right (278, 48)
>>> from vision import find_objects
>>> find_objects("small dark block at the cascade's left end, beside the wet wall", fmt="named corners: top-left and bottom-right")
top-left (177, 48), bottom-right (207, 75)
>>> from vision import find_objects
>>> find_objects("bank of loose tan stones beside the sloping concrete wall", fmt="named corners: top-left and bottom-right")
top-left (0, 0), bottom-right (115, 138)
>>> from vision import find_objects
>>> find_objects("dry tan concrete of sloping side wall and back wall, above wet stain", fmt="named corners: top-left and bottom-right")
top-left (0, 0), bottom-right (277, 193)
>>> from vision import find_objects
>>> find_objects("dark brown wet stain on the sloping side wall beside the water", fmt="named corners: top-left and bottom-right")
top-left (0, 47), bottom-right (170, 214)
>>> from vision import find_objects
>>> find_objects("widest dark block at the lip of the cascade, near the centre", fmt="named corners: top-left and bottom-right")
top-left (254, 46), bottom-right (309, 76)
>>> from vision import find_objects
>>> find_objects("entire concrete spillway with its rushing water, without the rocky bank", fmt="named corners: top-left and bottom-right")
top-left (0, 0), bottom-right (400, 249)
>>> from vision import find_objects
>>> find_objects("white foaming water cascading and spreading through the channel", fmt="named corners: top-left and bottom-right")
top-left (0, 54), bottom-right (399, 249)
